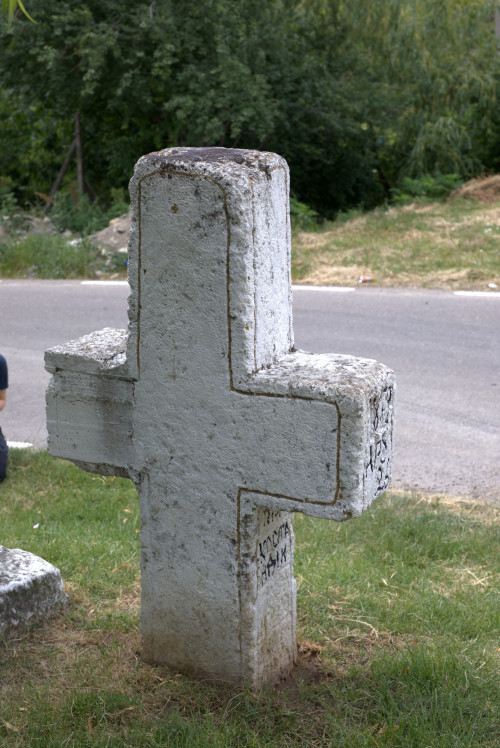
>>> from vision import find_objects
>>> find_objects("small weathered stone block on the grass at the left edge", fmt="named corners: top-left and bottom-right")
top-left (0, 545), bottom-right (69, 635)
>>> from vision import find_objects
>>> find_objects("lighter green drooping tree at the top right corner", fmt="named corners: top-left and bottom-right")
top-left (341, 0), bottom-right (499, 182)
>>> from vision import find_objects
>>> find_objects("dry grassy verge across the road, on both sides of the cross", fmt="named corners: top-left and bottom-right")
top-left (0, 191), bottom-right (500, 290)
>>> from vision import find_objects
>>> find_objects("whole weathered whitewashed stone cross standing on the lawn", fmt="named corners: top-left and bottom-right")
top-left (46, 148), bottom-right (394, 688)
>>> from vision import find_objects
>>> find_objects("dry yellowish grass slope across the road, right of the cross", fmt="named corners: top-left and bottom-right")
top-left (292, 197), bottom-right (500, 290)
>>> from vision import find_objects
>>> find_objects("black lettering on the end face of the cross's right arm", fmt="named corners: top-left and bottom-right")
top-left (365, 387), bottom-right (394, 494)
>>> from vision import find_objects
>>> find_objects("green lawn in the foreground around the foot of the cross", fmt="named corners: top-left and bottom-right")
top-left (0, 450), bottom-right (500, 748)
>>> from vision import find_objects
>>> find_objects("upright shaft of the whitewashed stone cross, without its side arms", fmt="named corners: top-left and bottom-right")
top-left (129, 152), bottom-right (295, 684)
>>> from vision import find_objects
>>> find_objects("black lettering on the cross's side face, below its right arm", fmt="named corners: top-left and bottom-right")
top-left (256, 508), bottom-right (293, 587)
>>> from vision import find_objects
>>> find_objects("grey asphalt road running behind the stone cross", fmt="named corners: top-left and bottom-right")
top-left (0, 280), bottom-right (500, 500)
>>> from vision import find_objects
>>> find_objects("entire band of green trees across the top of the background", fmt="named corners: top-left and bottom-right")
top-left (0, 0), bottom-right (500, 216)
